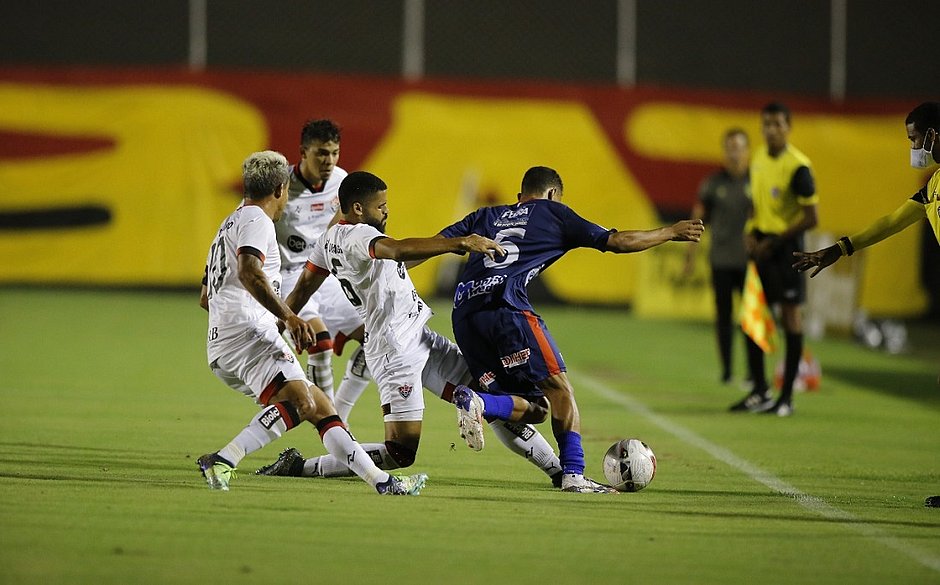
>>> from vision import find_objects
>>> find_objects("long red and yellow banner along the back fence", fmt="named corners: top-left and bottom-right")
top-left (0, 69), bottom-right (927, 316)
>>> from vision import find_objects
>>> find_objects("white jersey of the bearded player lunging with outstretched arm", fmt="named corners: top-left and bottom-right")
top-left (307, 222), bottom-right (431, 359)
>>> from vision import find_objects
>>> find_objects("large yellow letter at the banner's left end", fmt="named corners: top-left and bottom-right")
top-left (0, 83), bottom-right (267, 286)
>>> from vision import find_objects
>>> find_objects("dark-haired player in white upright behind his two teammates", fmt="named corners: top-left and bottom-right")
top-left (275, 120), bottom-right (370, 421)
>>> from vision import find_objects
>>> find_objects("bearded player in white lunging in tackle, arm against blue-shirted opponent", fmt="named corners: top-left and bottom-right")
top-left (253, 171), bottom-right (560, 480)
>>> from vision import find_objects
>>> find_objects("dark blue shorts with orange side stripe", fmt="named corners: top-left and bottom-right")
top-left (453, 306), bottom-right (566, 398)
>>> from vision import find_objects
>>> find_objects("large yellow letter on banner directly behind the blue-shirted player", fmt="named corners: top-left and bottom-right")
top-left (364, 93), bottom-right (658, 303)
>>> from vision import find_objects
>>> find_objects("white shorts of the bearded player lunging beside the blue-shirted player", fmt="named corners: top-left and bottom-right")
top-left (366, 327), bottom-right (471, 422)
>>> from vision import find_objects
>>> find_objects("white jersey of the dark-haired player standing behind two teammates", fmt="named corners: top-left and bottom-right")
top-left (275, 165), bottom-right (347, 274)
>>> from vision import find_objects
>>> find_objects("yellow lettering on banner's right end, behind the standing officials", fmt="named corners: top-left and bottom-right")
top-left (624, 103), bottom-right (928, 317)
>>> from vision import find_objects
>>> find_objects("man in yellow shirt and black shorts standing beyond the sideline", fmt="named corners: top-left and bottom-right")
top-left (731, 102), bottom-right (819, 416)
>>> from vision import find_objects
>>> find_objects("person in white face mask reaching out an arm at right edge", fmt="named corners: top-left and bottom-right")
top-left (793, 102), bottom-right (940, 508)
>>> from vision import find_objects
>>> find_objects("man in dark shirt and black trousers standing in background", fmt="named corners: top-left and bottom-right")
top-left (685, 128), bottom-right (767, 393)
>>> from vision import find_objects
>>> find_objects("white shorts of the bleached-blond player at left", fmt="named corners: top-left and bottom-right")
top-left (209, 328), bottom-right (307, 404)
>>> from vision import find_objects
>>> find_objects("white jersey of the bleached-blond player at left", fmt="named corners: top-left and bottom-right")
top-left (206, 205), bottom-right (281, 362)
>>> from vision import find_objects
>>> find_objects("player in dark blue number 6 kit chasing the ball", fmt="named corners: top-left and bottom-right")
top-left (439, 167), bottom-right (705, 493)
